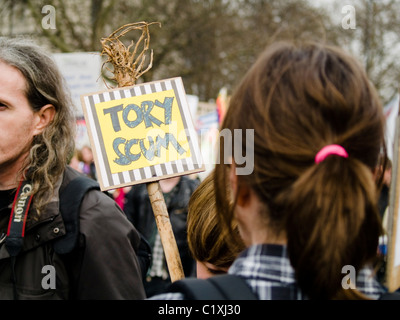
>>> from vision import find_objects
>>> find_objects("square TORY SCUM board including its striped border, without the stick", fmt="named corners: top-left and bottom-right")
top-left (81, 77), bottom-right (204, 190)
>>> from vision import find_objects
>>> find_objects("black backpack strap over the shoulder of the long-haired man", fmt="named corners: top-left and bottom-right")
top-left (53, 176), bottom-right (100, 254)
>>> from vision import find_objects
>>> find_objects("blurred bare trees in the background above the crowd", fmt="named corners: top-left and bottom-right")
top-left (5, 0), bottom-right (400, 102)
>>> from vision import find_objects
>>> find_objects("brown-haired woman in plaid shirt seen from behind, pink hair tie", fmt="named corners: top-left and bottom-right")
top-left (150, 42), bottom-right (386, 300)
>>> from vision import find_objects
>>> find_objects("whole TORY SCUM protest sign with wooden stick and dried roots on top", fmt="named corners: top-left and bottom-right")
top-left (90, 21), bottom-right (197, 282)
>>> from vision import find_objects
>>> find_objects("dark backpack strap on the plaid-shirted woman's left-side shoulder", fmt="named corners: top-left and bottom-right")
top-left (168, 274), bottom-right (258, 300)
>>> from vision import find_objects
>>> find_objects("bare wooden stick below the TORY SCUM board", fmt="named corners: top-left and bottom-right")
top-left (147, 181), bottom-right (185, 282)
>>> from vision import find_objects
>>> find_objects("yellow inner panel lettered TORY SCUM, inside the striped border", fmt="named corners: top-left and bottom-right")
top-left (95, 89), bottom-right (191, 173)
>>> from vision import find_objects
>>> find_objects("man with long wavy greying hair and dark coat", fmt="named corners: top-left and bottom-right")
top-left (0, 38), bottom-right (145, 299)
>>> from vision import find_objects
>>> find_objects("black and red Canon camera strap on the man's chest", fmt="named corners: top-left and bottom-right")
top-left (5, 181), bottom-right (32, 257)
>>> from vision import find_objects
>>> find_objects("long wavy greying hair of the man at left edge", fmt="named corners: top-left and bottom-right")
top-left (0, 37), bottom-right (75, 212)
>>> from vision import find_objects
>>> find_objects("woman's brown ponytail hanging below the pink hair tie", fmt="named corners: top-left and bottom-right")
top-left (279, 156), bottom-right (382, 299)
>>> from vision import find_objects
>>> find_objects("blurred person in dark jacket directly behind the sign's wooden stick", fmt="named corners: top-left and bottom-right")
top-left (124, 176), bottom-right (199, 297)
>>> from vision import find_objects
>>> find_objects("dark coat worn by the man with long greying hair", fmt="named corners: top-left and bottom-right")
top-left (0, 167), bottom-right (145, 299)
